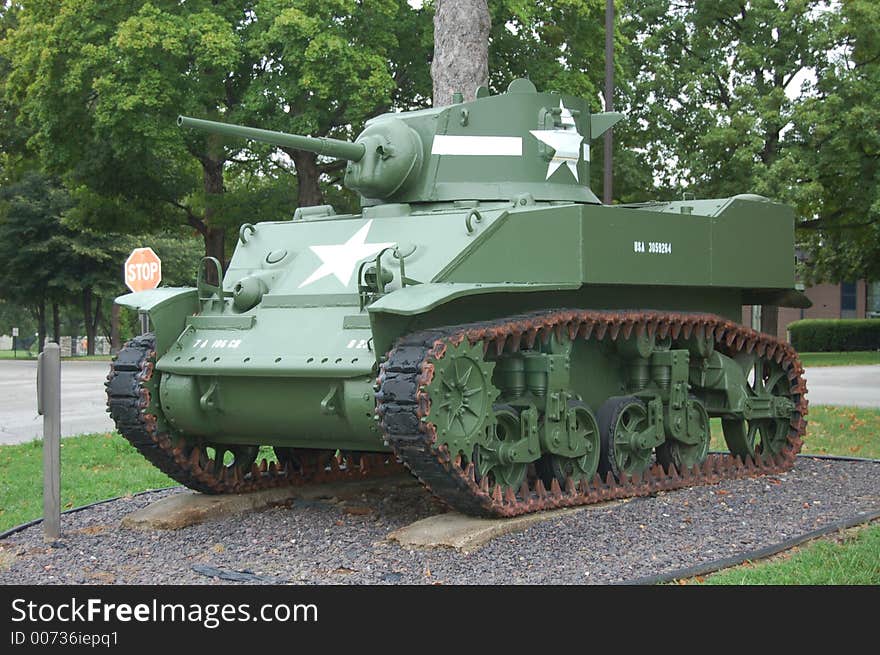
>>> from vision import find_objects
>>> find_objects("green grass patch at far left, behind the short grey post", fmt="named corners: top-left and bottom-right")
top-left (0, 433), bottom-right (177, 531)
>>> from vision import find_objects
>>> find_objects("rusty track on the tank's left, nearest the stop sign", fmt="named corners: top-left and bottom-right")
top-left (105, 334), bottom-right (404, 494)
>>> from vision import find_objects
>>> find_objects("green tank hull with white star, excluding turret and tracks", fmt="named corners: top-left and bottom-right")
top-left (124, 199), bottom-right (793, 452)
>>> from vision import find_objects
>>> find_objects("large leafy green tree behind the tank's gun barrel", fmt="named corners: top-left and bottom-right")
top-left (0, 0), bottom-right (427, 261)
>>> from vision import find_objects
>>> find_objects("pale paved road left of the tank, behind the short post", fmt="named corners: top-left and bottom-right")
top-left (0, 359), bottom-right (114, 444)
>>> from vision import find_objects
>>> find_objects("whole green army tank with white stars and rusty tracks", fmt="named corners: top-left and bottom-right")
top-left (107, 80), bottom-right (809, 516)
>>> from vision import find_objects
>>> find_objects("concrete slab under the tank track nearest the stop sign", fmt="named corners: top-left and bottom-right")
top-left (121, 475), bottom-right (419, 530)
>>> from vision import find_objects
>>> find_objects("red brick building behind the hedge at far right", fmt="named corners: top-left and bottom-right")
top-left (742, 280), bottom-right (880, 340)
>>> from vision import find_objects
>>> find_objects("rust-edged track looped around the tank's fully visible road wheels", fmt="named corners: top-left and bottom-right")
top-left (377, 310), bottom-right (807, 516)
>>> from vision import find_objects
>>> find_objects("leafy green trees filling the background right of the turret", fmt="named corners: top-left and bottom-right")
top-left (623, 0), bottom-right (880, 282)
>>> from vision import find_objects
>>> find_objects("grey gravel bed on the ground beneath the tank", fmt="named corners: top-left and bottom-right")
top-left (0, 458), bottom-right (880, 584)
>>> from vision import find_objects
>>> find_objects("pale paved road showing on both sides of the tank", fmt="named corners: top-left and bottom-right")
top-left (0, 360), bottom-right (880, 444)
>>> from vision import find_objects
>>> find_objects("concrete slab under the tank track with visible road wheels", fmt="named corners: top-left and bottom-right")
top-left (388, 499), bottom-right (632, 553)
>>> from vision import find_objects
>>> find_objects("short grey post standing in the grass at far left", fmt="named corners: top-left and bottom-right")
top-left (37, 343), bottom-right (61, 541)
